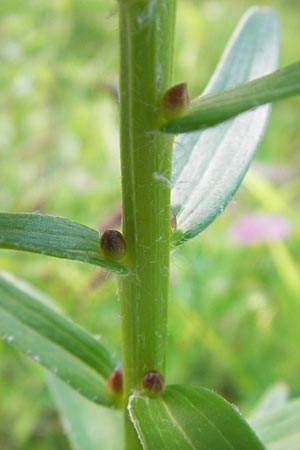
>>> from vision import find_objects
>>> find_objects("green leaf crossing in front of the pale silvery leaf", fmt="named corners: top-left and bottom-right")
top-left (161, 62), bottom-right (300, 133)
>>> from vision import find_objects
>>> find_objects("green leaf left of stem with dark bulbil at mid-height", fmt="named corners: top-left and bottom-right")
top-left (0, 213), bottom-right (128, 274)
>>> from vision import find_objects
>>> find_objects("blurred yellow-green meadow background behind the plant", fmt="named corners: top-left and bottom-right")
top-left (0, 0), bottom-right (300, 450)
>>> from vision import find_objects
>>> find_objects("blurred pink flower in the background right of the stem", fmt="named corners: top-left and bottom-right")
top-left (227, 212), bottom-right (290, 245)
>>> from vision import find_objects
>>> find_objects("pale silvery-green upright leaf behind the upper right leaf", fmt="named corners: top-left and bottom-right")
top-left (171, 8), bottom-right (279, 243)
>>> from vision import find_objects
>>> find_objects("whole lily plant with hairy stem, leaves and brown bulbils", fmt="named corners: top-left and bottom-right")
top-left (0, 0), bottom-right (300, 450)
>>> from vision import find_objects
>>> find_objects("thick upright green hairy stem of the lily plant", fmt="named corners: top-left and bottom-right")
top-left (120, 0), bottom-right (176, 450)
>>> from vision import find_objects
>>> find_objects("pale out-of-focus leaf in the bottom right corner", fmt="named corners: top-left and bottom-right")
top-left (249, 398), bottom-right (300, 450)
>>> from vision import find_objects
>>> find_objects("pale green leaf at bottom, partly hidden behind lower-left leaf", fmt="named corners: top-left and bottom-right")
top-left (47, 375), bottom-right (123, 450)
